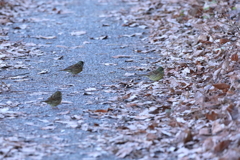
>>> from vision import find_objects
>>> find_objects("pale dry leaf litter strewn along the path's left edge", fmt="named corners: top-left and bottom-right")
top-left (0, 0), bottom-right (72, 159)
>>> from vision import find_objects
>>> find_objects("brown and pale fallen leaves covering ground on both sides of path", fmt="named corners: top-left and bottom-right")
top-left (0, 0), bottom-right (240, 160)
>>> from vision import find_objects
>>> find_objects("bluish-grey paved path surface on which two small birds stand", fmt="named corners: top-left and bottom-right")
top-left (0, 0), bottom-right (152, 160)
